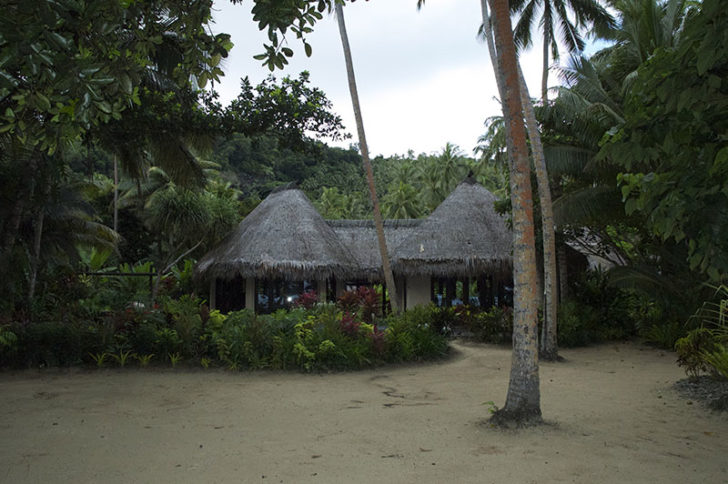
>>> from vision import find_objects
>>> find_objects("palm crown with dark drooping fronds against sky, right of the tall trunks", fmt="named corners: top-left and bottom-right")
top-left (510, 0), bottom-right (615, 104)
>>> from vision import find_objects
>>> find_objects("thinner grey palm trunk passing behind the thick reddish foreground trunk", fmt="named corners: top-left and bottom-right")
top-left (480, 0), bottom-right (558, 361)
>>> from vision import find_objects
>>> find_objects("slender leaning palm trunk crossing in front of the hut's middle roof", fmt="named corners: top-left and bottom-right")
top-left (335, 3), bottom-right (399, 313)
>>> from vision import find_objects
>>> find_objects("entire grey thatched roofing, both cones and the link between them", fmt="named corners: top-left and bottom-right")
top-left (196, 179), bottom-right (512, 280)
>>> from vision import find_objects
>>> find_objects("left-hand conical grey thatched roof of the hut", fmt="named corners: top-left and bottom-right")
top-left (196, 186), bottom-right (357, 280)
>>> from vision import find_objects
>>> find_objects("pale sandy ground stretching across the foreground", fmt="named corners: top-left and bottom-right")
top-left (0, 342), bottom-right (728, 483)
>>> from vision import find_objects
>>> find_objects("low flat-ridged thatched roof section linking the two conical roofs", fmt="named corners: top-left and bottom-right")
top-left (326, 219), bottom-right (424, 280)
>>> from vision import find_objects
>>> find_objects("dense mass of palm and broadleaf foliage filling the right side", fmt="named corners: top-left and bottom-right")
top-left (524, 0), bottom-right (728, 347)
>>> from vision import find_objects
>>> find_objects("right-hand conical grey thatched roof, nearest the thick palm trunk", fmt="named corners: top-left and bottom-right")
top-left (392, 178), bottom-right (513, 276)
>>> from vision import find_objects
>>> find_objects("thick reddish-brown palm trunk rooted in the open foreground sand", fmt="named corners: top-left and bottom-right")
top-left (491, 0), bottom-right (541, 426)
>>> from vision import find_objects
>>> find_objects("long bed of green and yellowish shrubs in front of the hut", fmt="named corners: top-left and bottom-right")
top-left (0, 286), bottom-right (447, 371)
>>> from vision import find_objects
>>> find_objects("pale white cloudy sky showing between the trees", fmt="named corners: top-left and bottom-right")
top-left (214, 0), bottom-right (556, 156)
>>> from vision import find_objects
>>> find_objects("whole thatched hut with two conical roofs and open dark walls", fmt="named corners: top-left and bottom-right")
top-left (196, 178), bottom-right (512, 312)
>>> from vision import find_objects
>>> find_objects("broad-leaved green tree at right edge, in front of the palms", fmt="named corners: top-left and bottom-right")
top-left (599, 0), bottom-right (728, 284)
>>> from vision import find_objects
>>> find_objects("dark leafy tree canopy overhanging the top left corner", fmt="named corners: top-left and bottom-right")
top-left (0, 0), bottom-right (231, 300)
